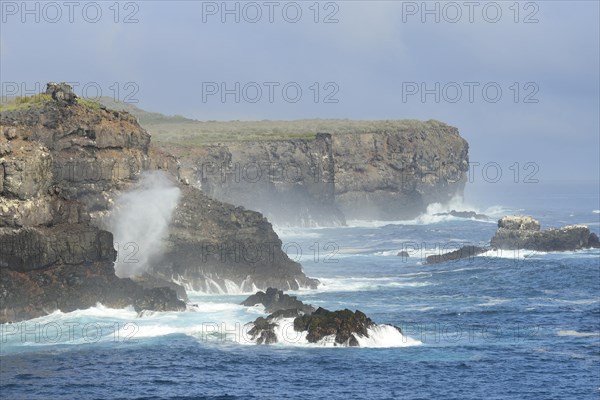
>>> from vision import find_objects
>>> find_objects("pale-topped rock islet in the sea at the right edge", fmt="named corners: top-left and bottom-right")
top-left (490, 216), bottom-right (600, 251)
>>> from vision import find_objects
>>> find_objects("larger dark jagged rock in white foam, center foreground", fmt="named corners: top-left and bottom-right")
top-left (294, 307), bottom-right (375, 346)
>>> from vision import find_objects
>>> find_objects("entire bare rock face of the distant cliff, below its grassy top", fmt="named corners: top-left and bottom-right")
top-left (163, 121), bottom-right (468, 226)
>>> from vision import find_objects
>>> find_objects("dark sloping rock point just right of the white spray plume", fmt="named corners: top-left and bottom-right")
top-left (157, 186), bottom-right (319, 292)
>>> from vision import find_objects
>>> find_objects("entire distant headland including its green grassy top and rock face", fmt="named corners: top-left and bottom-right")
top-left (105, 100), bottom-right (477, 226)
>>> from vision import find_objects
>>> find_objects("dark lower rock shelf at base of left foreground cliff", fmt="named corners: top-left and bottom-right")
top-left (0, 225), bottom-right (185, 323)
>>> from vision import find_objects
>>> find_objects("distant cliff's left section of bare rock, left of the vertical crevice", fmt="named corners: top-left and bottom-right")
top-left (169, 135), bottom-right (345, 226)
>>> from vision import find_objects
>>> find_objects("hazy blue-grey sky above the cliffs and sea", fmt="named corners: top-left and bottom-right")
top-left (0, 0), bottom-right (600, 203)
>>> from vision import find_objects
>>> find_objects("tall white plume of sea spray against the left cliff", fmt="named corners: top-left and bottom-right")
top-left (109, 171), bottom-right (181, 278)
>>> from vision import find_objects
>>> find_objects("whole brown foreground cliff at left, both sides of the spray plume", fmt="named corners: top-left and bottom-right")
top-left (0, 85), bottom-right (317, 322)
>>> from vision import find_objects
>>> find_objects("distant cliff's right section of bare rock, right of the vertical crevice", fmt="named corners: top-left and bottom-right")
top-left (333, 121), bottom-right (469, 220)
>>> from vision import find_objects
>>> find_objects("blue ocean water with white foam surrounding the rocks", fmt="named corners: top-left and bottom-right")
top-left (0, 185), bottom-right (600, 400)
